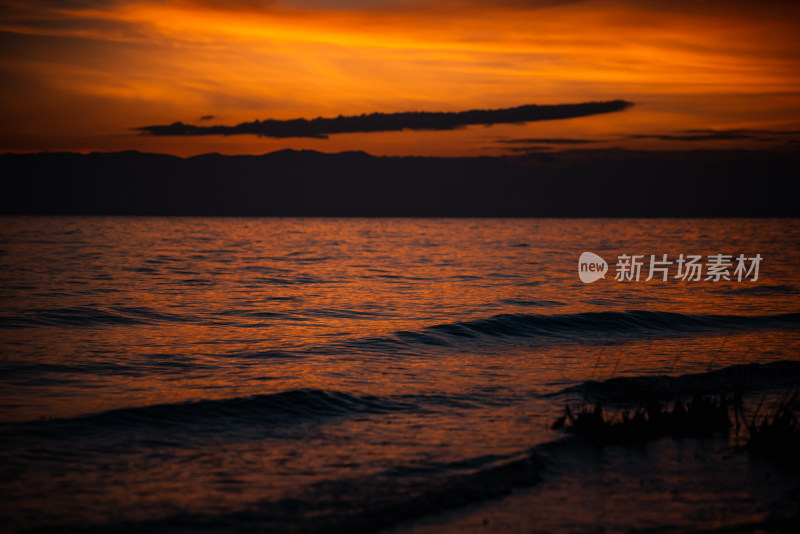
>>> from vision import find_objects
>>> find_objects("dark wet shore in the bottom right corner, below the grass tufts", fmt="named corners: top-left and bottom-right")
top-left (381, 437), bottom-right (800, 534)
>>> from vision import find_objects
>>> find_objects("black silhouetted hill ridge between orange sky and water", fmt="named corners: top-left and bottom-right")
top-left (0, 149), bottom-right (800, 217)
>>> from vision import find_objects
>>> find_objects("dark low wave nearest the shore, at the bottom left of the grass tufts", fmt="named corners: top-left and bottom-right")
top-left (23, 442), bottom-right (562, 534)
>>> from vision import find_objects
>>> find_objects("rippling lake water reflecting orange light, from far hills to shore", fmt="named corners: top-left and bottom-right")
top-left (0, 217), bottom-right (800, 532)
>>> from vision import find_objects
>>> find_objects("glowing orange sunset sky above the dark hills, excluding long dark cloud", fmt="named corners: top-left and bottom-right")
top-left (0, 0), bottom-right (800, 156)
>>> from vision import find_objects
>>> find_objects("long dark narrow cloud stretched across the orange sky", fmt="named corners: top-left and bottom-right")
top-left (139, 100), bottom-right (633, 139)
